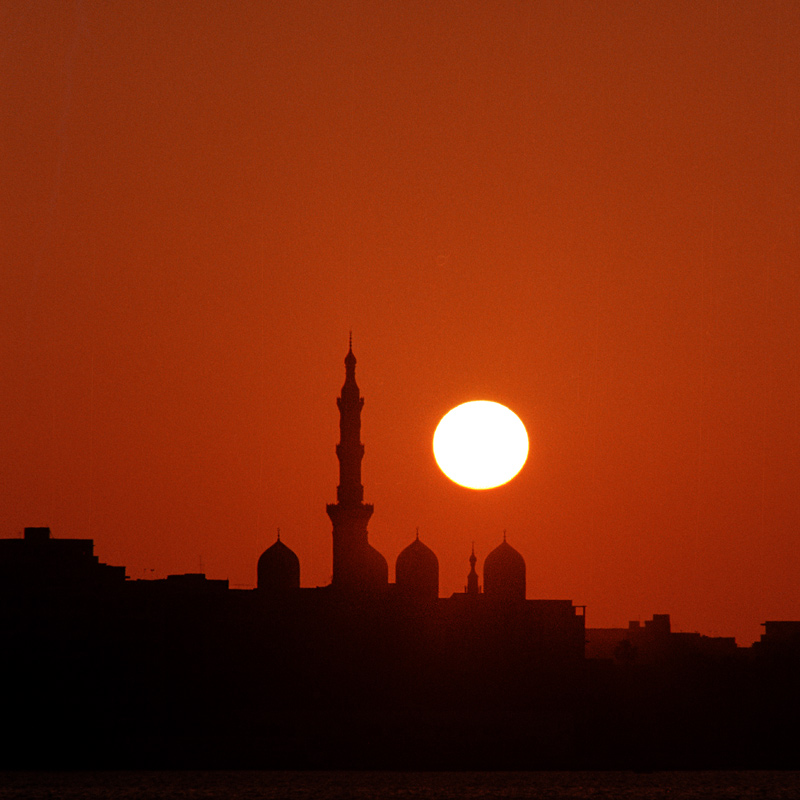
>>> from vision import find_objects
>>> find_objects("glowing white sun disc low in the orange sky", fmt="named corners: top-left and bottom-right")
top-left (433, 400), bottom-right (528, 489)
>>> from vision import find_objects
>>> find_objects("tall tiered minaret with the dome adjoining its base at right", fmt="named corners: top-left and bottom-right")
top-left (328, 335), bottom-right (389, 592)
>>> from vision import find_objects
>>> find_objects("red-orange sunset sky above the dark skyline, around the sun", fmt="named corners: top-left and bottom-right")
top-left (0, 0), bottom-right (800, 644)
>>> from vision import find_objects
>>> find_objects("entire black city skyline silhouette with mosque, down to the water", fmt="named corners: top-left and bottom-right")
top-left (0, 341), bottom-right (800, 769)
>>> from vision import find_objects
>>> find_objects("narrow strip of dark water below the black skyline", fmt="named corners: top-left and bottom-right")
top-left (0, 772), bottom-right (800, 800)
